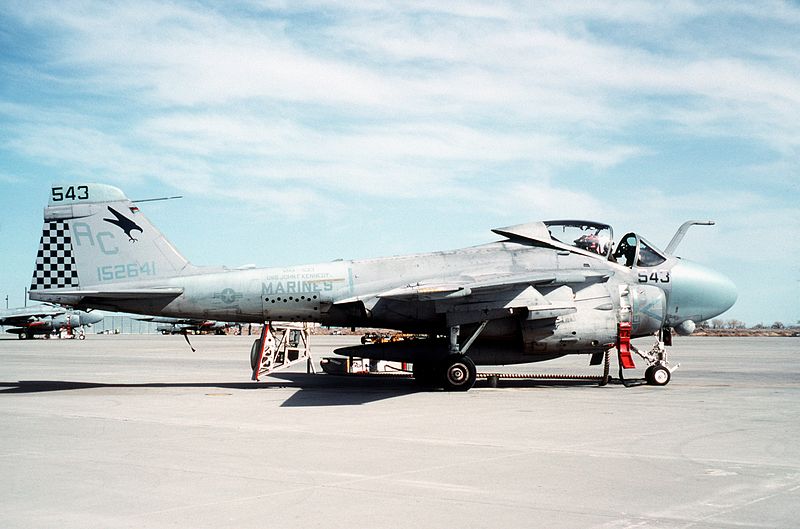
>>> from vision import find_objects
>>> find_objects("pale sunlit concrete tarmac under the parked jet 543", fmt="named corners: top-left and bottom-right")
top-left (0, 335), bottom-right (800, 529)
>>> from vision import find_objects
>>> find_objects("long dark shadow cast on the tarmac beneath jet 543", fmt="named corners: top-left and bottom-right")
top-left (0, 373), bottom-right (612, 407)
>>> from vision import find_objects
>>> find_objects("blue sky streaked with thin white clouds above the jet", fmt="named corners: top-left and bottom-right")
top-left (0, 0), bottom-right (800, 324)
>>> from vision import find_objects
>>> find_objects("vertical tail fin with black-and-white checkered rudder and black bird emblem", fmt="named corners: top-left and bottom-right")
top-left (31, 184), bottom-right (193, 292)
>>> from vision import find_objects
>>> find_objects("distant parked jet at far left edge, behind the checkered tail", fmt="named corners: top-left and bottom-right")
top-left (0, 305), bottom-right (103, 338)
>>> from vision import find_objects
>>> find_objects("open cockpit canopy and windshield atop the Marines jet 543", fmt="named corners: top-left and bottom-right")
top-left (492, 220), bottom-right (667, 267)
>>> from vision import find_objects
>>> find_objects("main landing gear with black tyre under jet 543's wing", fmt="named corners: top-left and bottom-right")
top-left (412, 321), bottom-right (489, 391)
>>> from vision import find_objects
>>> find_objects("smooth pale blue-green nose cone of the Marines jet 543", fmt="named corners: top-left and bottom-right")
top-left (668, 260), bottom-right (738, 325)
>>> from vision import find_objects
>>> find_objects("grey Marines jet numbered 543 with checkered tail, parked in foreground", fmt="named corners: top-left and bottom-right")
top-left (30, 184), bottom-right (737, 390)
